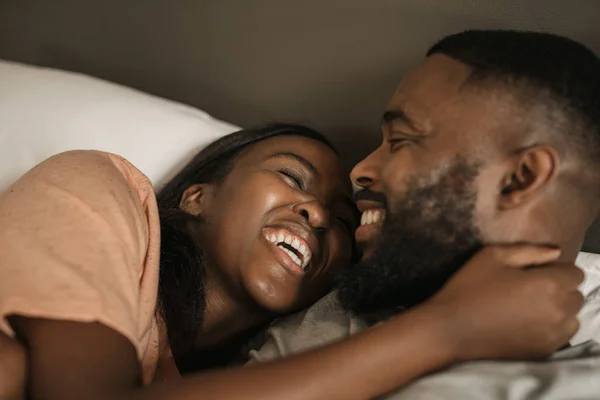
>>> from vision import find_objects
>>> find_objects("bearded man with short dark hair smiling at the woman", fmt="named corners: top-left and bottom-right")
top-left (253, 31), bottom-right (600, 399)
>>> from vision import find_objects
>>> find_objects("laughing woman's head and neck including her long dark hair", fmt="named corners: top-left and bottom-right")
top-left (158, 124), bottom-right (357, 371)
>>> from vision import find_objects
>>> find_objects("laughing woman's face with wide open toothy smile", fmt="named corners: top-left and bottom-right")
top-left (190, 136), bottom-right (357, 313)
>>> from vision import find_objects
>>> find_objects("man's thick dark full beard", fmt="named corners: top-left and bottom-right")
top-left (338, 158), bottom-right (482, 323)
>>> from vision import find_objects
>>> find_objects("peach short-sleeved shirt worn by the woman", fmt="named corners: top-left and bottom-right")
top-left (0, 151), bottom-right (168, 383)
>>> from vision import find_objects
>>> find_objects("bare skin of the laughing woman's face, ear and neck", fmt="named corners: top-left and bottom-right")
top-left (181, 136), bottom-right (357, 347)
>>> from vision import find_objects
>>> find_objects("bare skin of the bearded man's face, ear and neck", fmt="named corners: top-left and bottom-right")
top-left (351, 54), bottom-right (598, 261)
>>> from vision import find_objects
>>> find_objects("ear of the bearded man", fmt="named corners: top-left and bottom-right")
top-left (499, 145), bottom-right (560, 209)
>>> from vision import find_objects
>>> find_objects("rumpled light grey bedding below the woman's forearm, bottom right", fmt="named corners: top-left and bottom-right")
top-left (384, 341), bottom-right (600, 400)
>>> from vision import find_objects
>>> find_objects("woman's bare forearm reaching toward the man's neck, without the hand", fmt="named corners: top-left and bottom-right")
top-left (135, 309), bottom-right (454, 400)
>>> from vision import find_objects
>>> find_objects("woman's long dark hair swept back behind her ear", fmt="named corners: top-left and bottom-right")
top-left (157, 123), bottom-right (335, 372)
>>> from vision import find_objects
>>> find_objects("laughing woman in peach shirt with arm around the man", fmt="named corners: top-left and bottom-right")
top-left (0, 125), bottom-right (576, 399)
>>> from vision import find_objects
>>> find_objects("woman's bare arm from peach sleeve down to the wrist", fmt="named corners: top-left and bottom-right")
top-left (13, 304), bottom-right (453, 400)
